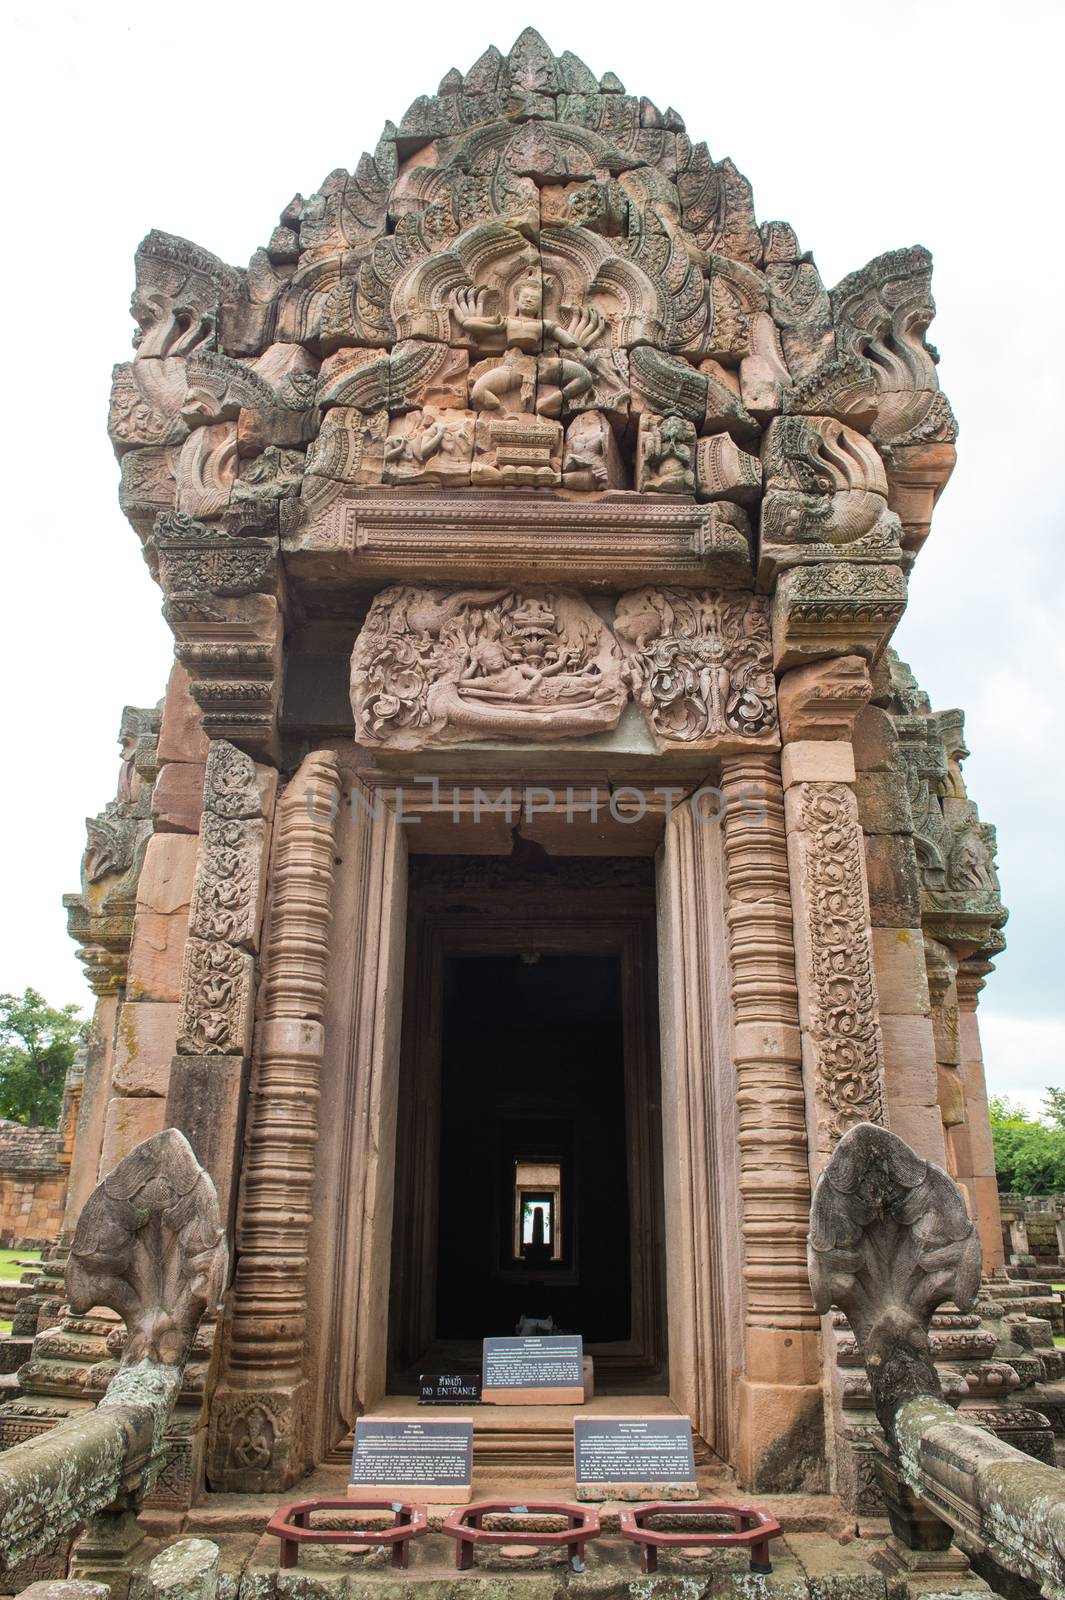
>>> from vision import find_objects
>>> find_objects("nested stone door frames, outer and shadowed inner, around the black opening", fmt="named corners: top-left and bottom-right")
top-left (305, 768), bottom-right (744, 1461)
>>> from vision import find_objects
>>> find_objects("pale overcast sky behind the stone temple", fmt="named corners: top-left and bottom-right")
top-left (0, 0), bottom-right (1065, 1107)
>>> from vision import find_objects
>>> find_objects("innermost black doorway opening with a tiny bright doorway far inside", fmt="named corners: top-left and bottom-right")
top-left (435, 952), bottom-right (632, 1342)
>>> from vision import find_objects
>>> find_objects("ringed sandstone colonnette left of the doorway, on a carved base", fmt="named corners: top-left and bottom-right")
top-left (209, 752), bottom-right (341, 1491)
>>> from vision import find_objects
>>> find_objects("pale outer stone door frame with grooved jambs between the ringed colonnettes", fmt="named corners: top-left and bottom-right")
top-left (284, 746), bottom-right (744, 1461)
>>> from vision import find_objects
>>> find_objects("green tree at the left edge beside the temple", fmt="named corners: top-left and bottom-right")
top-left (0, 989), bottom-right (86, 1128)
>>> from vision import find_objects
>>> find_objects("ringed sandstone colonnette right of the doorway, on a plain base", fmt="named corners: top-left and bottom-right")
top-left (721, 755), bottom-right (824, 1490)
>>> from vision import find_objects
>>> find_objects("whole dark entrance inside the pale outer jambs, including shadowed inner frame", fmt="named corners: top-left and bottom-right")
top-left (389, 856), bottom-right (668, 1395)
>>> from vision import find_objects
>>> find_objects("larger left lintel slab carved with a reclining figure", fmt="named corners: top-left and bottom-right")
top-left (352, 586), bottom-right (625, 749)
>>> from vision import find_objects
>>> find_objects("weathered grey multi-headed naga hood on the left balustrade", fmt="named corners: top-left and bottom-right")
top-left (66, 1128), bottom-right (225, 1366)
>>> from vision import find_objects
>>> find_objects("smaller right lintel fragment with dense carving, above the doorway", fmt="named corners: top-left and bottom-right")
top-left (614, 589), bottom-right (777, 752)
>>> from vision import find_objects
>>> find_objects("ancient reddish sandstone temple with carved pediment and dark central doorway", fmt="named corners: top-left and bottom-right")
top-left (0, 30), bottom-right (1023, 1542)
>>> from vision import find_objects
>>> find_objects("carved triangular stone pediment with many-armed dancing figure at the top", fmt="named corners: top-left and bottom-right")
top-left (112, 29), bottom-right (947, 604)
